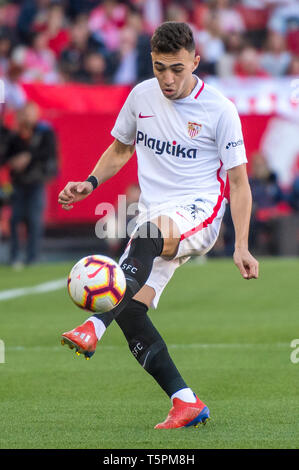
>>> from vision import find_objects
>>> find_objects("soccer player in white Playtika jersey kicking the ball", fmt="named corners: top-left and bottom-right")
top-left (59, 22), bottom-right (258, 429)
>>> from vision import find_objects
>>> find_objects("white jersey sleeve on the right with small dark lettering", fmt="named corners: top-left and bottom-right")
top-left (216, 101), bottom-right (247, 170)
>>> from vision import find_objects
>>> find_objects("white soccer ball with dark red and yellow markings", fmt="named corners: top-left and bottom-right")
top-left (68, 255), bottom-right (126, 313)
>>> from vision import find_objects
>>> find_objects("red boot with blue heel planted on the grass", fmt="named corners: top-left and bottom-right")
top-left (155, 397), bottom-right (210, 429)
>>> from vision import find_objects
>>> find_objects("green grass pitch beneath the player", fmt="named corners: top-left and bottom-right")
top-left (0, 259), bottom-right (299, 449)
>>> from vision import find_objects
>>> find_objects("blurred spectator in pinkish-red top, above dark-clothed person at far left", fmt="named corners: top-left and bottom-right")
top-left (12, 32), bottom-right (59, 83)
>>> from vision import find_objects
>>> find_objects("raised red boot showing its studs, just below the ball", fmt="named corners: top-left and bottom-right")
top-left (61, 321), bottom-right (98, 359)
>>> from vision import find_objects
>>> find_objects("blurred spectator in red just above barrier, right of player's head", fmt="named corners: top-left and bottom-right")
top-left (234, 46), bottom-right (268, 77)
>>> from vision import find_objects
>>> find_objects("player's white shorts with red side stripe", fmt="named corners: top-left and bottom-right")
top-left (119, 198), bottom-right (227, 308)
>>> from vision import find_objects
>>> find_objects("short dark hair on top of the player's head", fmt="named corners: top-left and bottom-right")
top-left (151, 21), bottom-right (195, 53)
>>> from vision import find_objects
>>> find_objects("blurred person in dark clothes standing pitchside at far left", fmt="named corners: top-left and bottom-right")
top-left (4, 102), bottom-right (57, 265)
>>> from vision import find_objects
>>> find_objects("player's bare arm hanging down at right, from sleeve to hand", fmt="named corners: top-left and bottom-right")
top-left (228, 164), bottom-right (259, 279)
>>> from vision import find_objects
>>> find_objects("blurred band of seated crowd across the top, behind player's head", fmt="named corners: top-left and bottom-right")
top-left (0, 0), bottom-right (299, 85)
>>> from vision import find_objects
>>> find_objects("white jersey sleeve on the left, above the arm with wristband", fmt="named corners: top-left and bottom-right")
top-left (111, 89), bottom-right (136, 145)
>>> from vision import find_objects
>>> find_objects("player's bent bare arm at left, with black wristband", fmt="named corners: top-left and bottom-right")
top-left (58, 139), bottom-right (135, 210)
